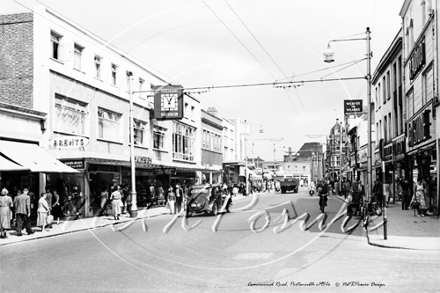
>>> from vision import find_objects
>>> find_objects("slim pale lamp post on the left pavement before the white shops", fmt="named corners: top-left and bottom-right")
top-left (127, 71), bottom-right (137, 218)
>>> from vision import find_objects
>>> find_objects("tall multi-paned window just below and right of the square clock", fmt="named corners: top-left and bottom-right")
top-left (172, 121), bottom-right (196, 161)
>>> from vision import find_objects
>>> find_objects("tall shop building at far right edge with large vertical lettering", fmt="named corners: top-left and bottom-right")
top-left (400, 0), bottom-right (439, 215)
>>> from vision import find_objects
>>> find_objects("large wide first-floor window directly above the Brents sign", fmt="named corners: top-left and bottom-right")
top-left (54, 94), bottom-right (88, 135)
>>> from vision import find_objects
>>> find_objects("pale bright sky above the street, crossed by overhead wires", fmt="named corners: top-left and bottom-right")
top-left (0, 0), bottom-right (403, 160)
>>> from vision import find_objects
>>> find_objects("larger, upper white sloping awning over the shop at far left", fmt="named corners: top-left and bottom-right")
top-left (0, 141), bottom-right (78, 173)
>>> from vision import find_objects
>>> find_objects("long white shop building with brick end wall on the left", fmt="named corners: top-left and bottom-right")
top-left (0, 6), bottom-right (203, 216)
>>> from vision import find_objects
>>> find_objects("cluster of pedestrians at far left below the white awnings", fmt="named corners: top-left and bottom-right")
top-left (0, 188), bottom-right (61, 238)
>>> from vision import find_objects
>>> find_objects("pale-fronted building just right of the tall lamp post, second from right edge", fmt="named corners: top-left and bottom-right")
top-left (372, 29), bottom-right (402, 195)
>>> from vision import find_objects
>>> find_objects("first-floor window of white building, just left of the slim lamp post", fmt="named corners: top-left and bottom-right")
top-left (98, 108), bottom-right (122, 142)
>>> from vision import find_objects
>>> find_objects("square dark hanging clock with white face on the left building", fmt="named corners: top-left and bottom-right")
top-left (153, 85), bottom-right (183, 120)
